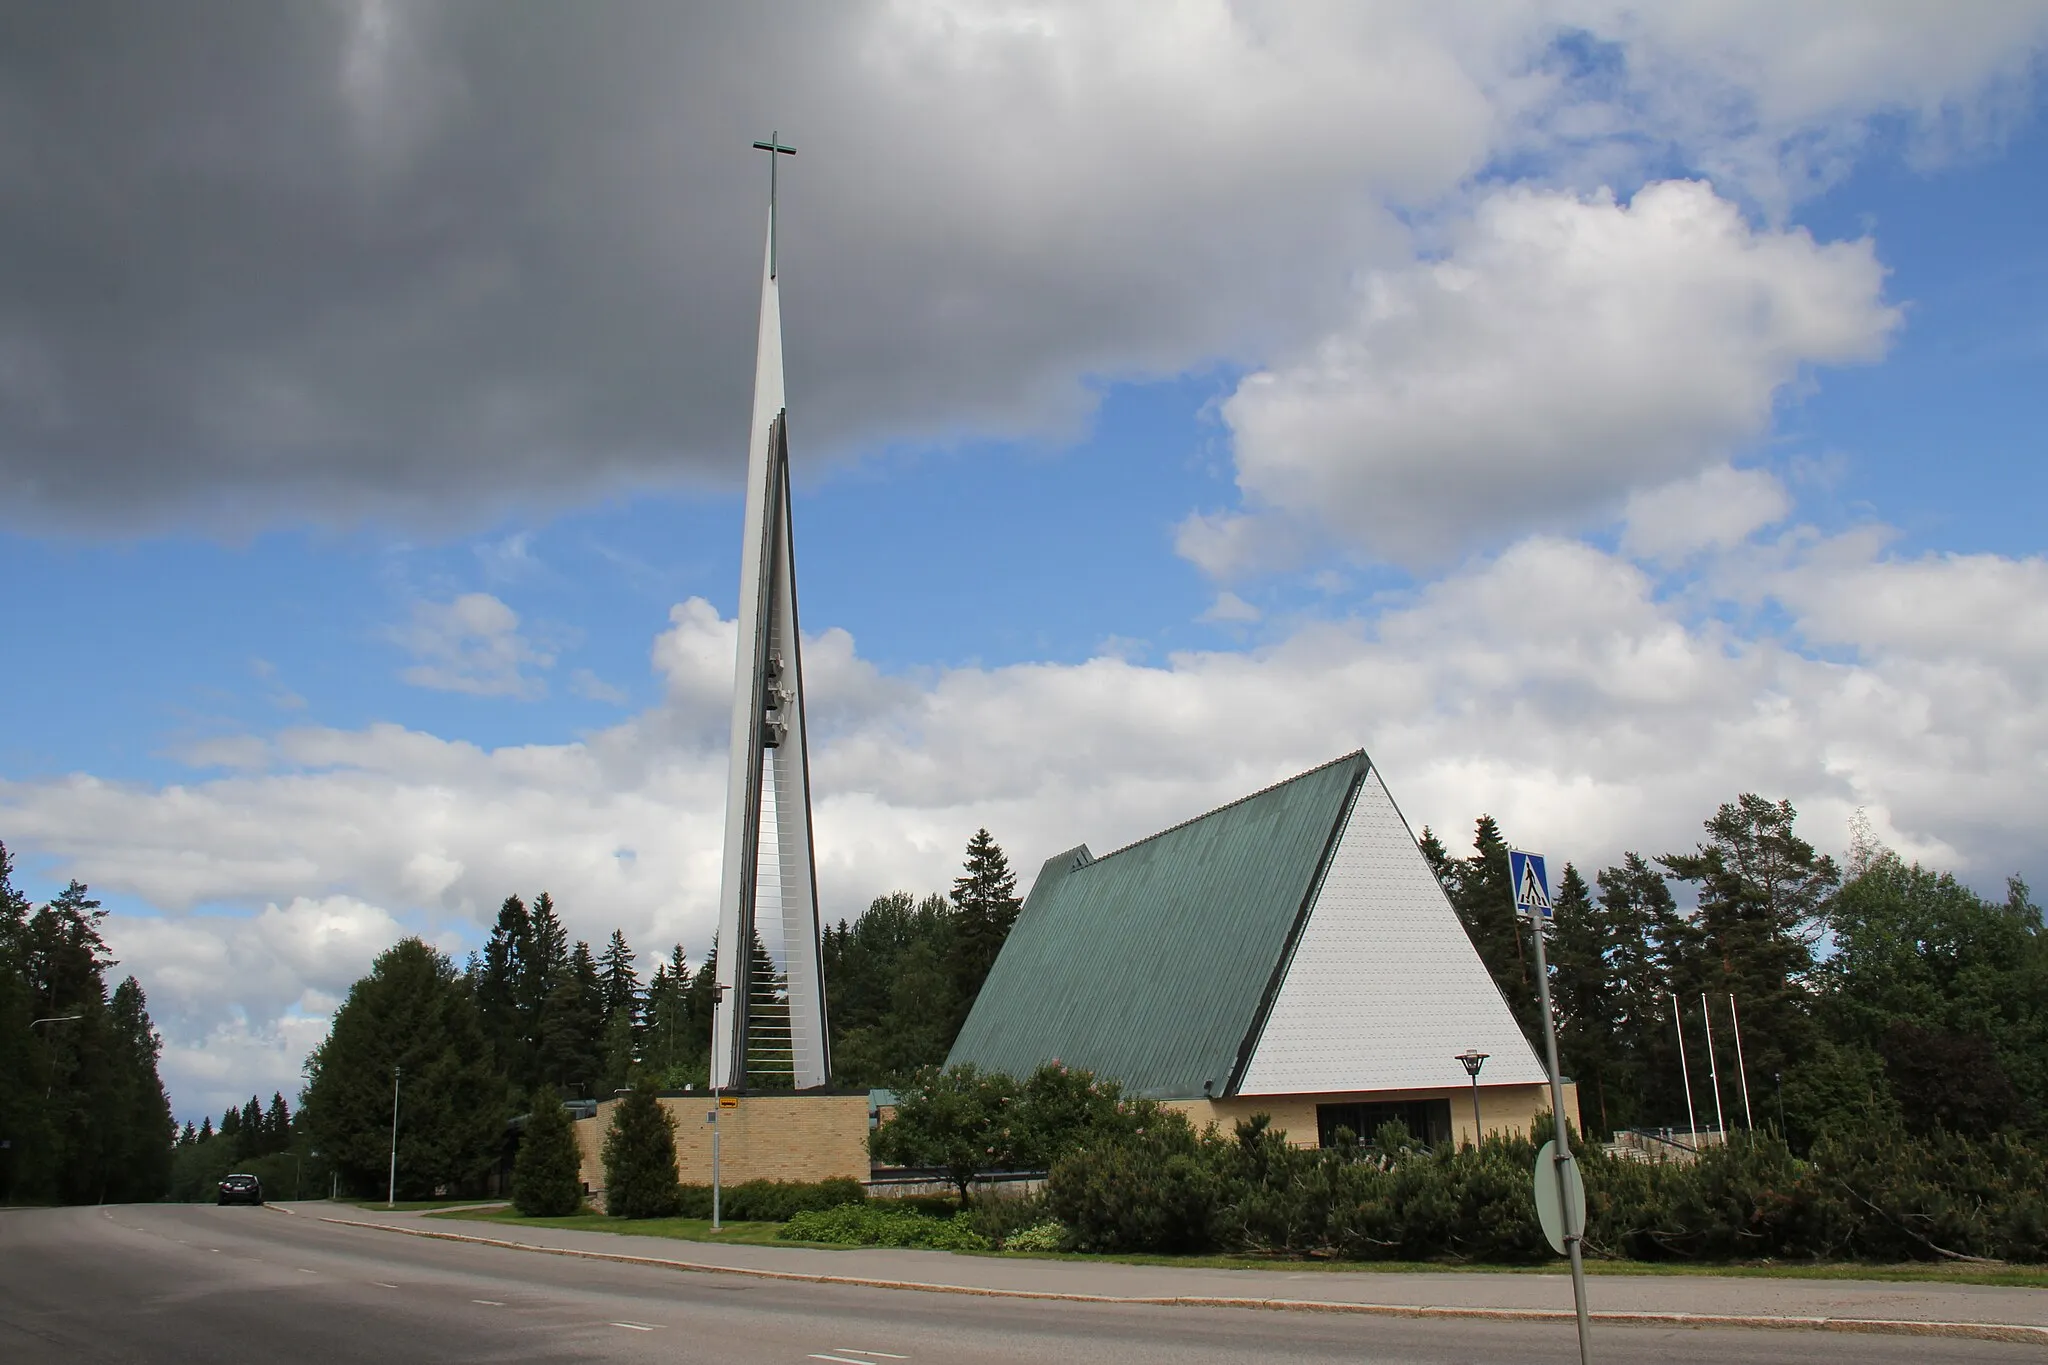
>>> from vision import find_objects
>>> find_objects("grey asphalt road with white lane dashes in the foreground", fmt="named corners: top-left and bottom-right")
top-left (0, 1205), bottom-right (2040, 1365)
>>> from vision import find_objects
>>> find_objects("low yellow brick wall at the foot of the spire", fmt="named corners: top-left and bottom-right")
top-left (575, 1093), bottom-right (868, 1191)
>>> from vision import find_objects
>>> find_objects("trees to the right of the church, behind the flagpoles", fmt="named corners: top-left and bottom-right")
top-left (1421, 794), bottom-right (2048, 1152)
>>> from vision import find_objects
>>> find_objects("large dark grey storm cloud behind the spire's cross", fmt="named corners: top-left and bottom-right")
top-left (0, 2), bottom-right (1487, 528)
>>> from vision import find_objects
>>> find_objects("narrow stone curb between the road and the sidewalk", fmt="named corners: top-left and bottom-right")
top-left (319, 1218), bottom-right (2048, 1347)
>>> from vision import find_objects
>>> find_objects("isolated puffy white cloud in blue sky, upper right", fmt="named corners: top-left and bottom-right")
top-left (1182, 182), bottom-right (1898, 575)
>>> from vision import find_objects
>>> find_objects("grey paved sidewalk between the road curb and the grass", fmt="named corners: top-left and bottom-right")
top-left (307, 1203), bottom-right (2048, 1345)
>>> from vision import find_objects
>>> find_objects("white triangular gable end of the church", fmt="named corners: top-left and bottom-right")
top-left (1239, 769), bottom-right (1544, 1095)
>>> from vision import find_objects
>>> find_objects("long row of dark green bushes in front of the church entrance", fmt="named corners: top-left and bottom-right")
top-left (1047, 1115), bottom-right (2048, 1263)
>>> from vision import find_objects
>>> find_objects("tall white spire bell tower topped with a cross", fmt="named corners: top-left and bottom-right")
top-left (711, 133), bottom-right (831, 1091)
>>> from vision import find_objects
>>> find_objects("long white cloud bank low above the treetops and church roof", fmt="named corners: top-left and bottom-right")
top-left (16, 528), bottom-right (2048, 1107)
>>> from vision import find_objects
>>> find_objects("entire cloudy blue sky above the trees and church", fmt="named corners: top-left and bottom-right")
top-left (0, 0), bottom-right (2048, 1119)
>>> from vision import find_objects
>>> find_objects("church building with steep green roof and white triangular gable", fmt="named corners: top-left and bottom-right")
top-left (946, 751), bottom-right (1577, 1146)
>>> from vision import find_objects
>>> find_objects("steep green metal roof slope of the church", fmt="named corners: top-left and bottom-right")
top-left (946, 753), bottom-right (1368, 1099)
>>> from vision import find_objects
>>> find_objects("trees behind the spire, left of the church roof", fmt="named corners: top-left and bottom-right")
top-left (299, 829), bottom-right (1022, 1195)
